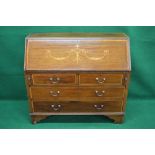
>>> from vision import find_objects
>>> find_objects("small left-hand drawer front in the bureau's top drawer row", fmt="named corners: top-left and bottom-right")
top-left (32, 73), bottom-right (77, 85)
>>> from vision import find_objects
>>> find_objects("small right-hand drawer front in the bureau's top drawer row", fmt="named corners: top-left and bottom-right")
top-left (79, 74), bottom-right (123, 85)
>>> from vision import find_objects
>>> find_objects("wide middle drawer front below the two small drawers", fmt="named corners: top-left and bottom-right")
top-left (31, 87), bottom-right (124, 101)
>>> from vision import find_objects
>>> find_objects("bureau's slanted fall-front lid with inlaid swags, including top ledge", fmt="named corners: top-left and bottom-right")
top-left (25, 33), bottom-right (131, 71)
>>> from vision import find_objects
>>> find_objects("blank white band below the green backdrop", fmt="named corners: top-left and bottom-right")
top-left (0, 129), bottom-right (155, 155)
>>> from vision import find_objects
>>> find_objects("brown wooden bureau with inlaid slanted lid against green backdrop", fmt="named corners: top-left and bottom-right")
top-left (24, 33), bottom-right (131, 123)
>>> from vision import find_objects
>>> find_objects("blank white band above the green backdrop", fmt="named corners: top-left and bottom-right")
top-left (0, 0), bottom-right (155, 26)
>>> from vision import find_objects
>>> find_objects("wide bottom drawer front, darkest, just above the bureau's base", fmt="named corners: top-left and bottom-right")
top-left (33, 101), bottom-right (122, 112)
